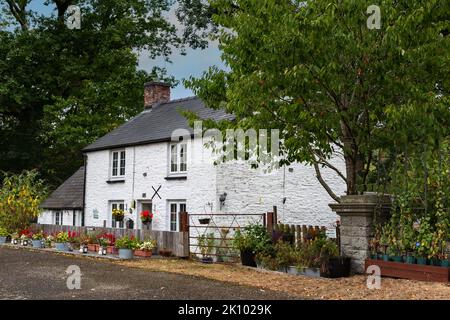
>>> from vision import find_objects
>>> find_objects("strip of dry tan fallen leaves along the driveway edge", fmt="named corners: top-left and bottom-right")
top-left (116, 259), bottom-right (450, 299)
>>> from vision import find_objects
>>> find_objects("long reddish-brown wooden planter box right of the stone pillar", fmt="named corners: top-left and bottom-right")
top-left (365, 259), bottom-right (450, 282)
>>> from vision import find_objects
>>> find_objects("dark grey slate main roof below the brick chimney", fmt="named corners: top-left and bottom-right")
top-left (83, 97), bottom-right (233, 152)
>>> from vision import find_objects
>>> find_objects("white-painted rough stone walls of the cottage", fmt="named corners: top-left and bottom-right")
top-left (39, 139), bottom-right (345, 230)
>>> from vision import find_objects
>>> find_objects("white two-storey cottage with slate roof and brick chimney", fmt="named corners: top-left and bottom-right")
top-left (39, 82), bottom-right (345, 231)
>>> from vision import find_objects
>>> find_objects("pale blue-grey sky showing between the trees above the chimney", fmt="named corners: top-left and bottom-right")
top-left (29, 0), bottom-right (225, 99)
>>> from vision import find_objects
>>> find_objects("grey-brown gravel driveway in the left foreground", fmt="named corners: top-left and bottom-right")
top-left (0, 247), bottom-right (292, 300)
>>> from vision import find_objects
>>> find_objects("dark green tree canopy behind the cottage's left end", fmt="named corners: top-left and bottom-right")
top-left (0, 0), bottom-right (184, 185)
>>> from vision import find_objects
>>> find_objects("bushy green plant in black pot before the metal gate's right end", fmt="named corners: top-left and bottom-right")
top-left (233, 224), bottom-right (271, 267)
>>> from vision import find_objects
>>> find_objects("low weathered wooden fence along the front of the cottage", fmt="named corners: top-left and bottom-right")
top-left (31, 224), bottom-right (189, 257)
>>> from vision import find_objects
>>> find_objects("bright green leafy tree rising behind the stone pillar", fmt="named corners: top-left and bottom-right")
top-left (187, 0), bottom-right (450, 201)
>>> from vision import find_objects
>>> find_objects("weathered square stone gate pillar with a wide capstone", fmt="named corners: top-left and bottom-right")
top-left (330, 193), bottom-right (391, 273)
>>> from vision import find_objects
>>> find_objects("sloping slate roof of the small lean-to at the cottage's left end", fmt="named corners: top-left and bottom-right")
top-left (40, 167), bottom-right (84, 210)
